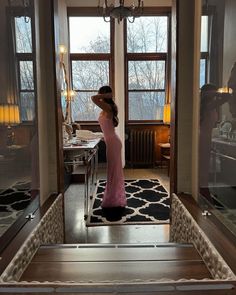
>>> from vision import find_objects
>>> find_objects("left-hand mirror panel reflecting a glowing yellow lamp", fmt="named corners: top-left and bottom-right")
top-left (0, 0), bottom-right (39, 252)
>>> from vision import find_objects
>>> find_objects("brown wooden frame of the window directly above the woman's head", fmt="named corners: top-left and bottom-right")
top-left (67, 7), bottom-right (115, 125)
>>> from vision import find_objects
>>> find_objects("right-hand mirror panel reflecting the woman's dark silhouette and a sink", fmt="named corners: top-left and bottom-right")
top-left (199, 0), bottom-right (236, 234)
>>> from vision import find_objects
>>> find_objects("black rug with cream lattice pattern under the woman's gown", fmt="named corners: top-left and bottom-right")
top-left (86, 179), bottom-right (170, 226)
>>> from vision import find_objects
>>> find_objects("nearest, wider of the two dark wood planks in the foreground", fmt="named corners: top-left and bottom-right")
top-left (20, 261), bottom-right (211, 283)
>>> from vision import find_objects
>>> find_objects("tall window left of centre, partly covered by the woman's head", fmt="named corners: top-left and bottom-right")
top-left (69, 16), bottom-right (113, 122)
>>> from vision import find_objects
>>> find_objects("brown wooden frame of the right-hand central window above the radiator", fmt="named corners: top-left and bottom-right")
top-left (124, 7), bottom-right (171, 125)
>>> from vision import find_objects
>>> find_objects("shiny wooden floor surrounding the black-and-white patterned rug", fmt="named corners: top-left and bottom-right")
top-left (65, 167), bottom-right (169, 244)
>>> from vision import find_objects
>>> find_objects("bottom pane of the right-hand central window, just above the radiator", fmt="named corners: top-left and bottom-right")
top-left (129, 91), bottom-right (165, 120)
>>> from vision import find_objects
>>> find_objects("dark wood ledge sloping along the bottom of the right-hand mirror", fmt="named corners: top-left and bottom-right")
top-left (178, 194), bottom-right (236, 273)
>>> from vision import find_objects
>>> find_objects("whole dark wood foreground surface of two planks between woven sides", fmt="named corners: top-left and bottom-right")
top-left (20, 243), bottom-right (212, 284)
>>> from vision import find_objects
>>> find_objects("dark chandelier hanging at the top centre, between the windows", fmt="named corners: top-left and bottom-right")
top-left (98, 0), bottom-right (143, 24)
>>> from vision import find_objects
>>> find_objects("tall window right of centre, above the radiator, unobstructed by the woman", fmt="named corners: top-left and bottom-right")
top-left (126, 15), bottom-right (169, 122)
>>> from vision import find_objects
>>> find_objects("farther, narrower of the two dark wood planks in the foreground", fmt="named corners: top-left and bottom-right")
top-left (32, 246), bottom-right (202, 262)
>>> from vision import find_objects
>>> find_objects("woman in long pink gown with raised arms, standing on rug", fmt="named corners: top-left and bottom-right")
top-left (92, 86), bottom-right (127, 213)
